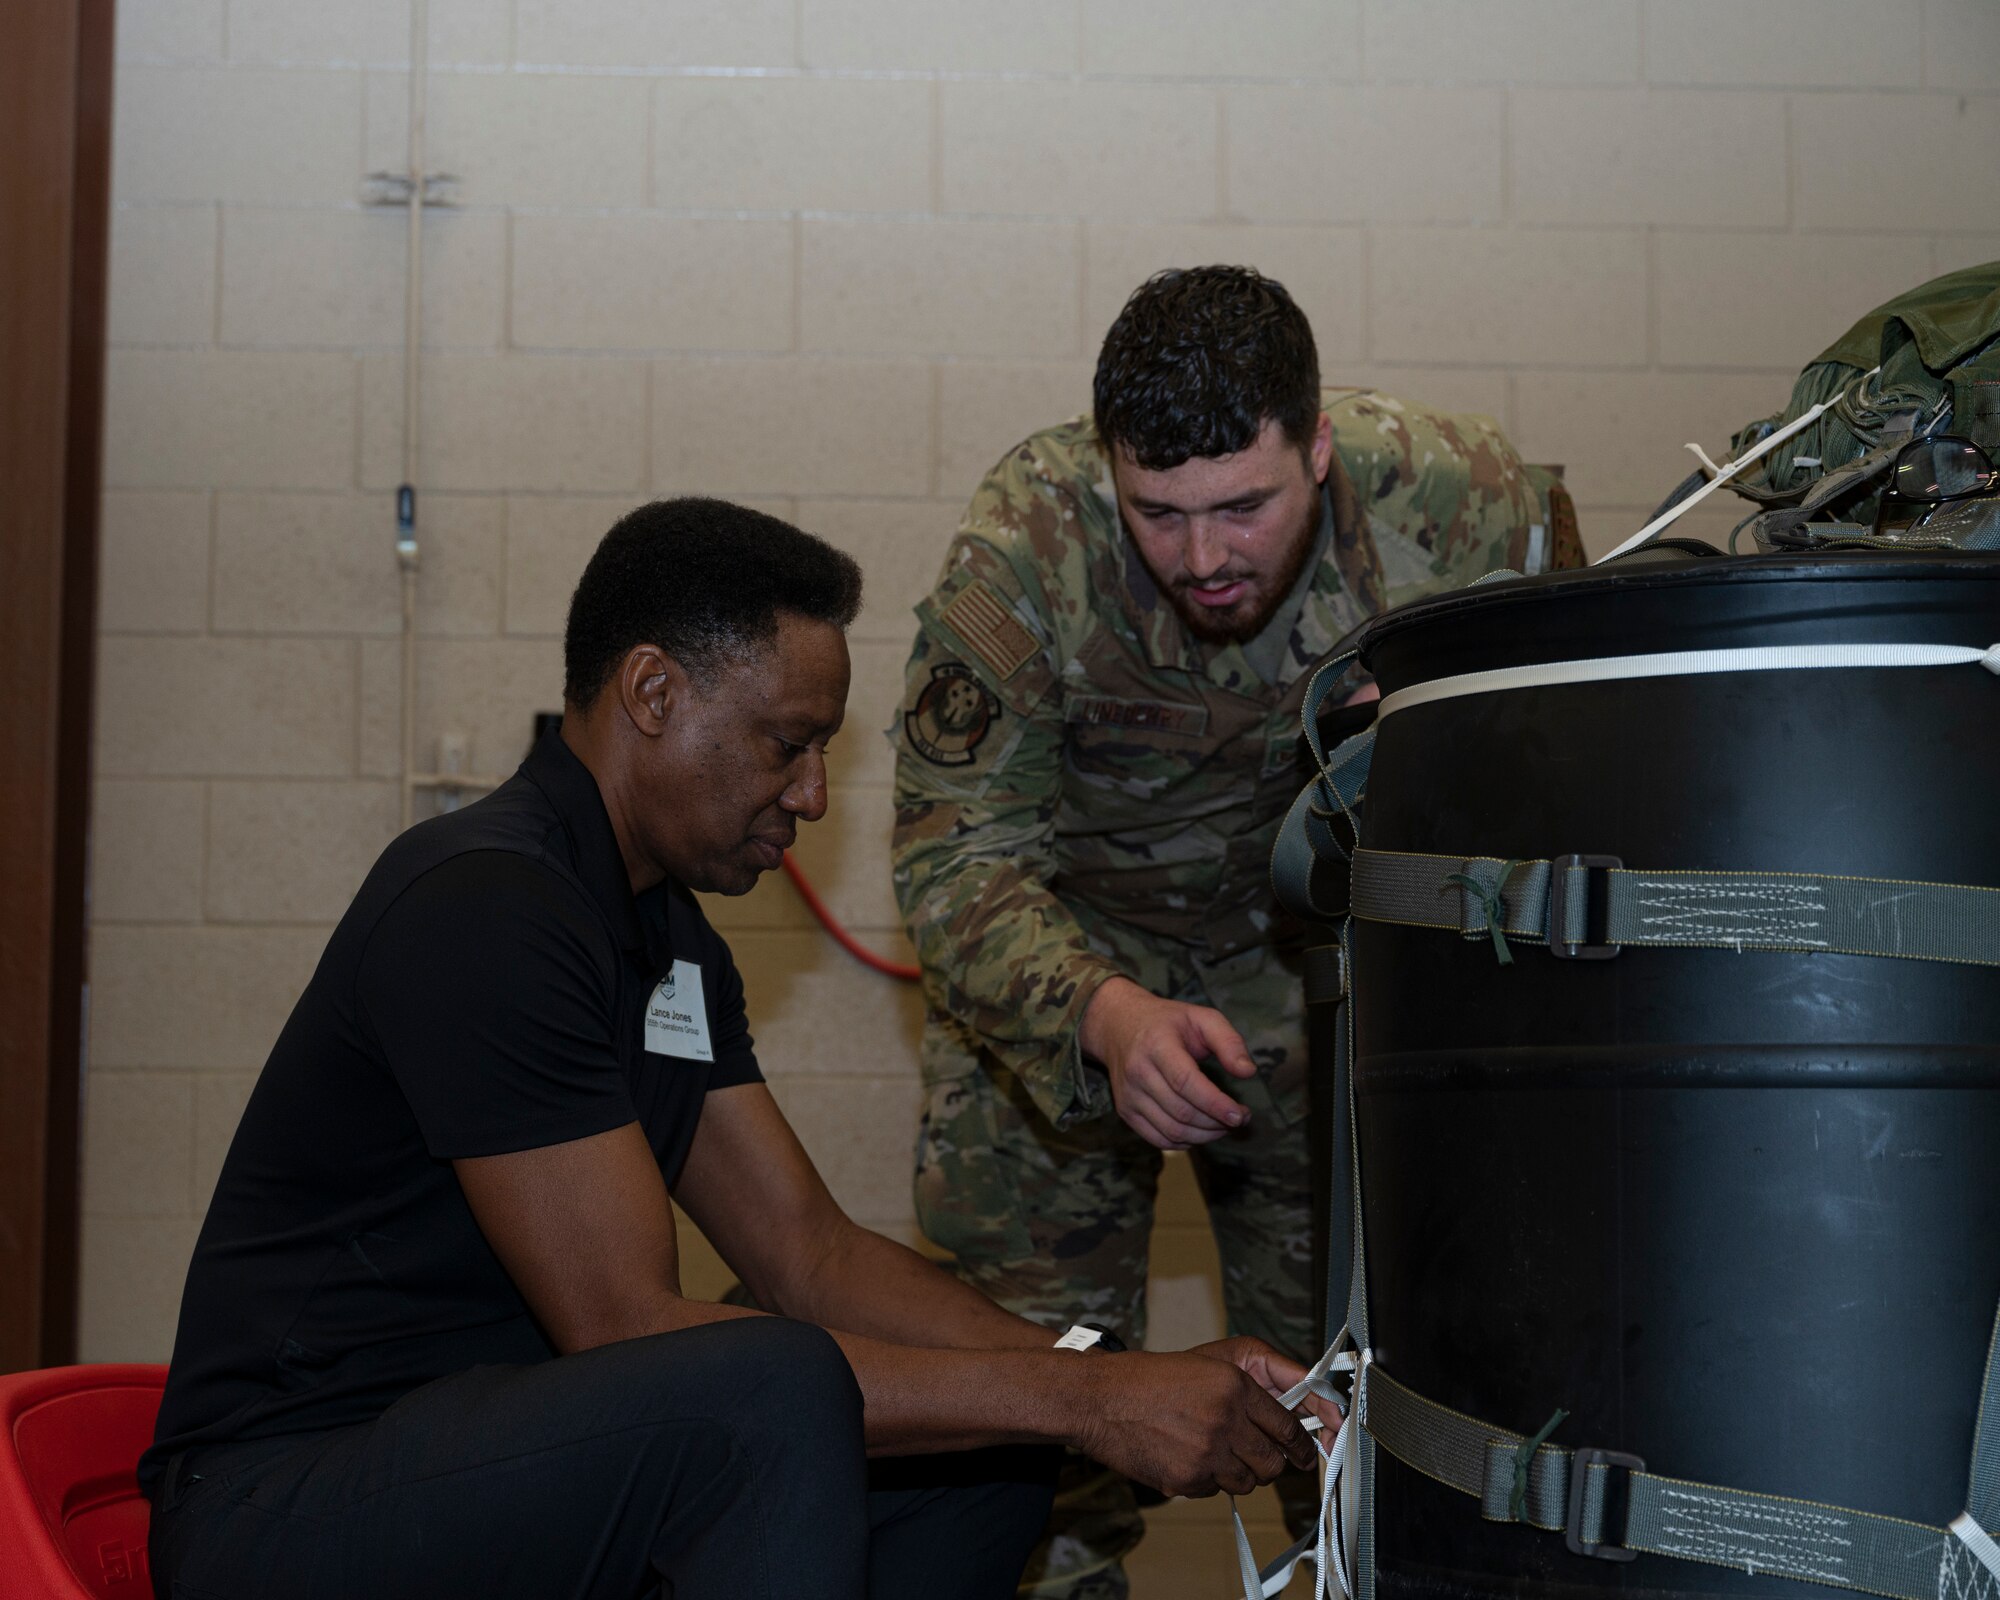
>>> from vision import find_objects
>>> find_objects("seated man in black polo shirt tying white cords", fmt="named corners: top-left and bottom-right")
top-left (140, 500), bottom-right (1336, 1600)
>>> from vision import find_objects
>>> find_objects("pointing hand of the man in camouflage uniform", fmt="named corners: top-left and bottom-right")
top-left (1078, 978), bottom-right (1256, 1150)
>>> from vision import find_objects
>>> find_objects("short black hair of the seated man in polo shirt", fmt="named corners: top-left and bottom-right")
top-left (562, 496), bottom-right (862, 706)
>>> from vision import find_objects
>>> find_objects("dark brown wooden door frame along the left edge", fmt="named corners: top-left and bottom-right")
top-left (0, 0), bottom-right (112, 1372)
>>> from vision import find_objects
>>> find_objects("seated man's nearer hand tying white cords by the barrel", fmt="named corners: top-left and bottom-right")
top-left (1074, 1340), bottom-right (1318, 1498)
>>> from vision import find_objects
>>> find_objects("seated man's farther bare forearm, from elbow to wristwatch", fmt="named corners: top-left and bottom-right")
top-left (780, 1218), bottom-right (1054, 1350)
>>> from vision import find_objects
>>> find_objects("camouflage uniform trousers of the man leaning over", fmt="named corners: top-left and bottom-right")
top-left (916, 948), bottom-right (1318, 1600)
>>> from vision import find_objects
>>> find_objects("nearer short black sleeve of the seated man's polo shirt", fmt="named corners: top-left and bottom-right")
top-left (356, 850), bottom-right (636, 1160)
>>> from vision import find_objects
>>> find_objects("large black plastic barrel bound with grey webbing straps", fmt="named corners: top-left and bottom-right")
top-left (1334, 552), bottom-right (2000, 1600)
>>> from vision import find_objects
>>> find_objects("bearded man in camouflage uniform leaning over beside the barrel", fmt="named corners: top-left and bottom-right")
top-left (890, 268), bottom-right (1574, 1600)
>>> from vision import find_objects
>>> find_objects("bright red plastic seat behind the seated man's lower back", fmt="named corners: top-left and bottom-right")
top-left (0, 1366), bottom-right (166, 1600)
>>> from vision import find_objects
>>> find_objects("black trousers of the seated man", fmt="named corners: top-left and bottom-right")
top-left (150, 1318), bottom-right (1056, 1600)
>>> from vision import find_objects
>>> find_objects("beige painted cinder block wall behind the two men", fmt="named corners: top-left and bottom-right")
top-left (84, 0), bottom-right (2000, 1592)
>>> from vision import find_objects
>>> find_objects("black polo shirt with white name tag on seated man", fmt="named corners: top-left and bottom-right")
top-left (140, 734), bottom-right (762, 1492)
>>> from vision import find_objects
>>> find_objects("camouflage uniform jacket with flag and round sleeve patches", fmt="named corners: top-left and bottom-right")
top-left (888, 390), bottom-right (1548, 1126)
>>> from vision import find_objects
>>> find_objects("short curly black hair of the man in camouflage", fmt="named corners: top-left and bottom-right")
top-left (1090, 266), bottom-right (1320, 472)
